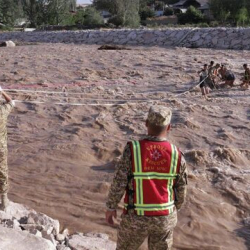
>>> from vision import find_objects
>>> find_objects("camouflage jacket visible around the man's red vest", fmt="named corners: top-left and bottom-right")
top-left (106, 136), bottom-right (187, 210)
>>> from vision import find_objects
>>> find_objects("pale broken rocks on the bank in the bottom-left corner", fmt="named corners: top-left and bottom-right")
top-left (0, 202), bottom-right (115, 250)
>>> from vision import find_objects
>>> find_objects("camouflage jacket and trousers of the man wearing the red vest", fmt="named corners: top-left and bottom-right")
top-left (106, 106), bottom-right (187, 250)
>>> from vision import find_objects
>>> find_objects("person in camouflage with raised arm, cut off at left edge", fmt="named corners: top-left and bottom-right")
top-left (0, 87), bottom-right (15, 210)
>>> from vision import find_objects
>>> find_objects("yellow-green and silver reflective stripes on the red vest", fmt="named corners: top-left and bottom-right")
top-left (125, 141), bottom-right (179, 215)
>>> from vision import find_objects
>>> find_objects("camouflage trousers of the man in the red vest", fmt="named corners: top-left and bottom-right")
top-left (116, 211), bottom-right (177, 250)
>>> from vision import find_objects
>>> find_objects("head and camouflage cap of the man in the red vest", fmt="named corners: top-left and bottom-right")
top-left (146, 105), bottom-right (172, 136)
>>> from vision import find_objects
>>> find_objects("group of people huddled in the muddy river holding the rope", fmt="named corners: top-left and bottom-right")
top-left (198, 61), bottom-right (250, 99)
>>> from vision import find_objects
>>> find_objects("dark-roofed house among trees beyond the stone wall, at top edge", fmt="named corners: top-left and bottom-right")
top-left (171, 0), bottom-right (211, 17)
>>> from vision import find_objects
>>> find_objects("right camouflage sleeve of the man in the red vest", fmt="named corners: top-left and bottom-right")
top-left (175, 155), bottom-right (187, 210)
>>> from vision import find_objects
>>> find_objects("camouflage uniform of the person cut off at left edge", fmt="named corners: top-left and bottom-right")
top-left (0, 102), bottom-right (14, 195)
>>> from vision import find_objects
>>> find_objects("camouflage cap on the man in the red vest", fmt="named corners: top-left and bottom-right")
top-left (147, 105), bottom-right (172, 126)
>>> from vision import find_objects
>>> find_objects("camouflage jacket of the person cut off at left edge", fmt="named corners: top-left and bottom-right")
top-left (0, 101), bottom-right (15, 149)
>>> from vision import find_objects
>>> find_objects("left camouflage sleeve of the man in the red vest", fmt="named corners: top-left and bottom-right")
top-left (106, 145), bottom-right (132, 209)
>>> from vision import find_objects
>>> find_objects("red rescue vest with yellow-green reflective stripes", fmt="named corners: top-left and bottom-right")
top-left (124, 140), bottom-right (181, 216)
